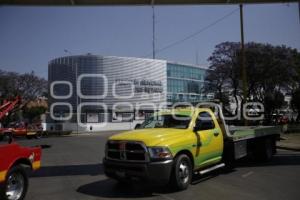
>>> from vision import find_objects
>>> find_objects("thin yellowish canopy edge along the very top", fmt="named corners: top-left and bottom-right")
top-left (0, 0), bottom-right (299, 5)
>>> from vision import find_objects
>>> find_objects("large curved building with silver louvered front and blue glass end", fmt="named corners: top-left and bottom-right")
top-left (48, 54), bottom-right (206, 132)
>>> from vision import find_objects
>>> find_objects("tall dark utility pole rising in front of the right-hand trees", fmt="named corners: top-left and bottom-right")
top-left (240, 4), bottom-right (248, 125)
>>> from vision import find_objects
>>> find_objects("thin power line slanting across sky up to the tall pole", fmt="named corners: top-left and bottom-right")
top-left (144, 8), bottom-right (239, 57)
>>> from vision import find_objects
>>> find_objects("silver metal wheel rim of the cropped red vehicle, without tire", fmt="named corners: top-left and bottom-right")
top-left (6, 173), bottom-right (25, 200)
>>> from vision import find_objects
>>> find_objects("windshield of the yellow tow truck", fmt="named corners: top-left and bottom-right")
top-left (141, 114), bottom-right (191, 129)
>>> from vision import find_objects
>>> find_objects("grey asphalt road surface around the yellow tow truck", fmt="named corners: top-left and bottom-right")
top-left (20, 133), bottom-right (300, 200)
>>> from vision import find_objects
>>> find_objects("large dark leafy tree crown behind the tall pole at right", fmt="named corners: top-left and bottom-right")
top-left (206, 42), bottom-right (300, 122)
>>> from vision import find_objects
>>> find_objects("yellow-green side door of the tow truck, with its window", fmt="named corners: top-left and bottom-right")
top-left (194, 111), bottom-right (223, 167)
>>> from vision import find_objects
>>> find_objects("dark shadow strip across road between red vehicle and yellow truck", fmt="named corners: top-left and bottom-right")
top-left (31, 163), bottom-right (103, 177)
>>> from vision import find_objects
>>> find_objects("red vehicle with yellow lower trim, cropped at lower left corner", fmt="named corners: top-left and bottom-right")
top-left (0, 137), bottom-right (41, 200)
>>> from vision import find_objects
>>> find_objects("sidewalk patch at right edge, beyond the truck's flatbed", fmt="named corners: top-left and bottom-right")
top-left (277, 133), bottom-right (300, 151)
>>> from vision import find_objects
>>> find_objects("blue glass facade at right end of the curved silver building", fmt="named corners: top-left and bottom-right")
top-left (167, 63), bottom-right (206, 103)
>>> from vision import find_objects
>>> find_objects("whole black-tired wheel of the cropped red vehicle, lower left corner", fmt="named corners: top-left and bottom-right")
top-left (0, 165), bottom-right (28, 200)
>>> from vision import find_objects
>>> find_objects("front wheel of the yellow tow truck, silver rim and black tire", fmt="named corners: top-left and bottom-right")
top-left (171, 154), bottom-right (192, 190)
